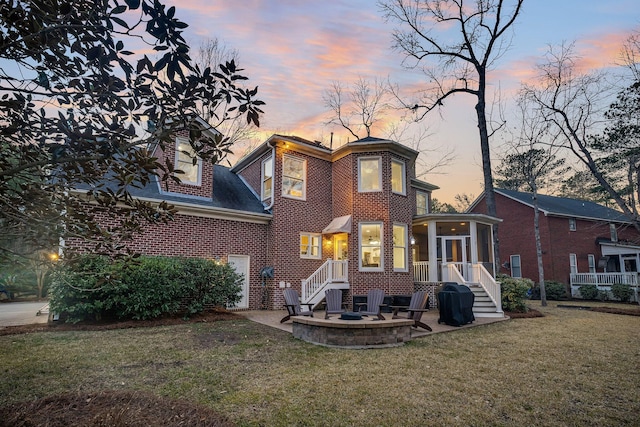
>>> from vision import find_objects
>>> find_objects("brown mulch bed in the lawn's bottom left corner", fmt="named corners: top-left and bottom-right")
top-left (0, 391), bottom-right (235, 427)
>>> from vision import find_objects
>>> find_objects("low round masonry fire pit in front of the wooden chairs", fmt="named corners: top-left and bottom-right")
top-left (292, 316), bottom-right (414, 349)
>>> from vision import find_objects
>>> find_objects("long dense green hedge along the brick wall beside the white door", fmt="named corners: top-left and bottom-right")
top-left (50, 255), bottom-right (242, 322)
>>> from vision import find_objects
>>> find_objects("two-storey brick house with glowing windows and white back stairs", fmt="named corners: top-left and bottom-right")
top-left (68, 125), bottom-right (502, 315)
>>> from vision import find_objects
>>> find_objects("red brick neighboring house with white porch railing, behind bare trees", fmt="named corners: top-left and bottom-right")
top-left (468, 189), bottom-right (640, 302)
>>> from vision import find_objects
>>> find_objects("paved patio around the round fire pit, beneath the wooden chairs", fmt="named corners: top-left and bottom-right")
top-left (238, 308), bottom-right (509, 338)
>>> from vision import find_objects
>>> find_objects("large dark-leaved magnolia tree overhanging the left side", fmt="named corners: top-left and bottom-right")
top-left (0, 0), bottom-right (263, 258)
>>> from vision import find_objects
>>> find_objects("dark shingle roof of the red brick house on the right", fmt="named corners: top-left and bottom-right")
top-left (495, 188), bottom-right (629, 223)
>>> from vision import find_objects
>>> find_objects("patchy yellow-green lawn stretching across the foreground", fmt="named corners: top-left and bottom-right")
top-left (0, 302), bottom-right (640, 426)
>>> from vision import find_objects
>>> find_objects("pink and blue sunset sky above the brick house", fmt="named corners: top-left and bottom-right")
top-left (166, 0), bottom-right (640, 202)
